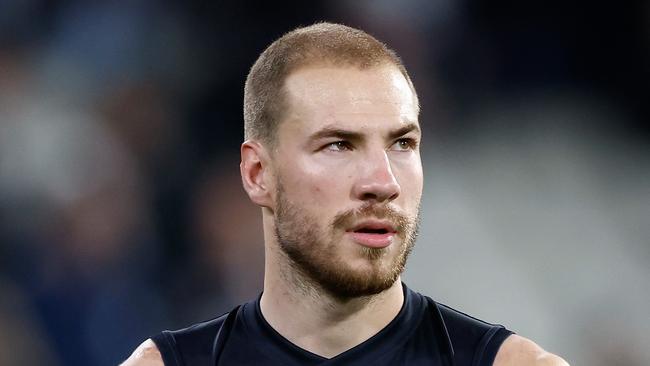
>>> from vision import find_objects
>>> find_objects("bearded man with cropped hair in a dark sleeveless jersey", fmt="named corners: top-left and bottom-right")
top-left (125, 23), bottom-right (567, 366)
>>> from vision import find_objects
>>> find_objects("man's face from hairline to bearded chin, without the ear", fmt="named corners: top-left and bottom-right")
top-left (272, 65), bottom-right (422, 298)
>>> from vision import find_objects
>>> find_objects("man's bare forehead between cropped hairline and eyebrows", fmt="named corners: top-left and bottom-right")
top-left (283, 65), bottom-right (418, 130)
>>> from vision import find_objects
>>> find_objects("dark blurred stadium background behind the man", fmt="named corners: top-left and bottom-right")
top-left (0, 0), bottom-right (650, 366)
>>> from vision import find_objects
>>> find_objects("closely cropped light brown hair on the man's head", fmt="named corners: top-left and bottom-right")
top-left (244, 22), bottom-right (419, 146)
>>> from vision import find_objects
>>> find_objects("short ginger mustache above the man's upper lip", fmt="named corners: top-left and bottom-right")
top-left (331, 203), bottom-right (413, 233)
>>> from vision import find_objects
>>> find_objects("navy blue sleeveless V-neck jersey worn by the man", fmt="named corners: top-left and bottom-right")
top-left (152, 286), bottom-right (512, 366)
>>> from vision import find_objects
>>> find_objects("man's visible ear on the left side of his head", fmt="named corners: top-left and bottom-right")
top-left (239, 140), bottom-right (273, 207)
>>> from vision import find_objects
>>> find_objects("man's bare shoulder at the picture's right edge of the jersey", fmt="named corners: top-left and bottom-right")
top-left (494, 334), bottom-right (569, 366)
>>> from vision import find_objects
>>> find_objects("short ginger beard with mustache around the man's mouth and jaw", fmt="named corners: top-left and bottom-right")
top-left (275, 182), bottom-right (419, 299)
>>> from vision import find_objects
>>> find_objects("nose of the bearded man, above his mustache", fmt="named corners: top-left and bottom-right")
top-left (352, 151), bottom-right (400, 203)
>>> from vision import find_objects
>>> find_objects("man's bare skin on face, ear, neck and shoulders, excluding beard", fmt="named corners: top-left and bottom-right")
top-left (124, 65), bottom-right (567, 366)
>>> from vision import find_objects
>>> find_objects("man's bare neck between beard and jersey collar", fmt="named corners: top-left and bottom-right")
top-left (260, 243), bottom-right (404, 358)
